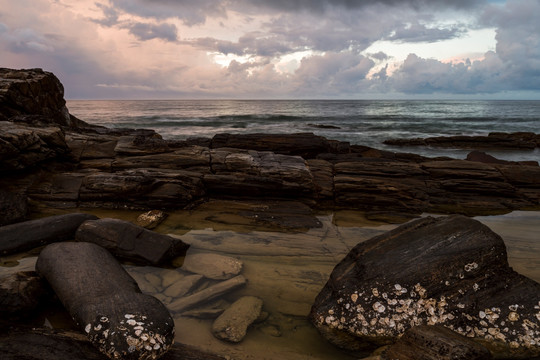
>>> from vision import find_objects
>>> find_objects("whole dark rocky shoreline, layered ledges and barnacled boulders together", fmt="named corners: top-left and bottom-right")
top-left (0, 69), bottom-right (540, 360)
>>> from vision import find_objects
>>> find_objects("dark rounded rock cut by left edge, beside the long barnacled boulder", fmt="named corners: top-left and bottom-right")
top-left (0, 271), bottom-right (51, 320)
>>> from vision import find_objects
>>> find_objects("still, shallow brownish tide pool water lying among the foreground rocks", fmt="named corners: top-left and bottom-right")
top-left (0, 205), bottom-right (540, 360)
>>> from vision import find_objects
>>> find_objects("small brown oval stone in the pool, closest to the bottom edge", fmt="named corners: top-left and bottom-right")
top-left (212, 296), bottom-right (263, 343)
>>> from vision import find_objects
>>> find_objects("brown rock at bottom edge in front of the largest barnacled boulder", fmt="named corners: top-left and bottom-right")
top-left (383, 325), bottom-right (492, 360)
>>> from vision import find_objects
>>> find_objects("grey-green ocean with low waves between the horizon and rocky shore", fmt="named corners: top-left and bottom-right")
top-left (67, 100), bottom-right (540, 161)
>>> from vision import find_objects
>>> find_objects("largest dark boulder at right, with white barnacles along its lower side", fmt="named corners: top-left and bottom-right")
top-left (310, 216), bottom-right (540, 357)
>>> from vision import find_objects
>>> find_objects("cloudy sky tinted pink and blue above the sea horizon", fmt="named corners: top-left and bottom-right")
top-left (0, 0), bottom-right (540, 99)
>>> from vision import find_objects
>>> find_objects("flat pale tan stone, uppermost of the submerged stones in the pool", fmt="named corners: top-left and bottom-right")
top-left (182, 253), bottom-right (243, 280)
